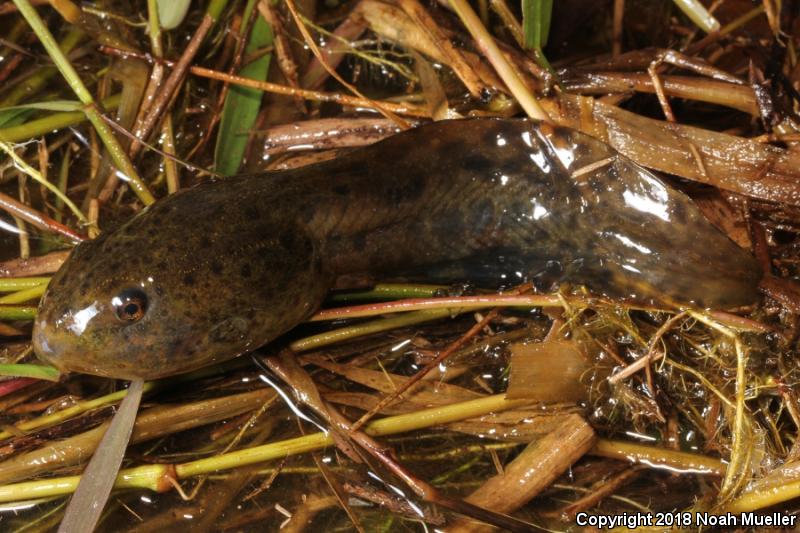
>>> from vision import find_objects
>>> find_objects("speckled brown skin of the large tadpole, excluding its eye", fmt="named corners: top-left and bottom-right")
top-left (33, 119), bottom-right (760, 379)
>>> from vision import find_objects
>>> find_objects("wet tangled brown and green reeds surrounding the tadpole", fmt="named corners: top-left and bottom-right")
top-left (0, 0), bottom-right (800, 532)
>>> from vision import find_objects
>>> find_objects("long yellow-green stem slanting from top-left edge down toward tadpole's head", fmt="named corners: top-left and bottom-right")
top-left (14, 0), bottom-right (155, 205)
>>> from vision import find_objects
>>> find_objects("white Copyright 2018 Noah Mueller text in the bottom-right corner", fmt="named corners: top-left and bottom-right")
top-left (575, 511), bottom-right (797, 529)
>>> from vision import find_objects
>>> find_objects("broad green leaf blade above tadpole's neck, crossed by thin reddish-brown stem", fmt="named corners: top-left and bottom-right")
top-left (214, 0), bottom-right (272, 176)
